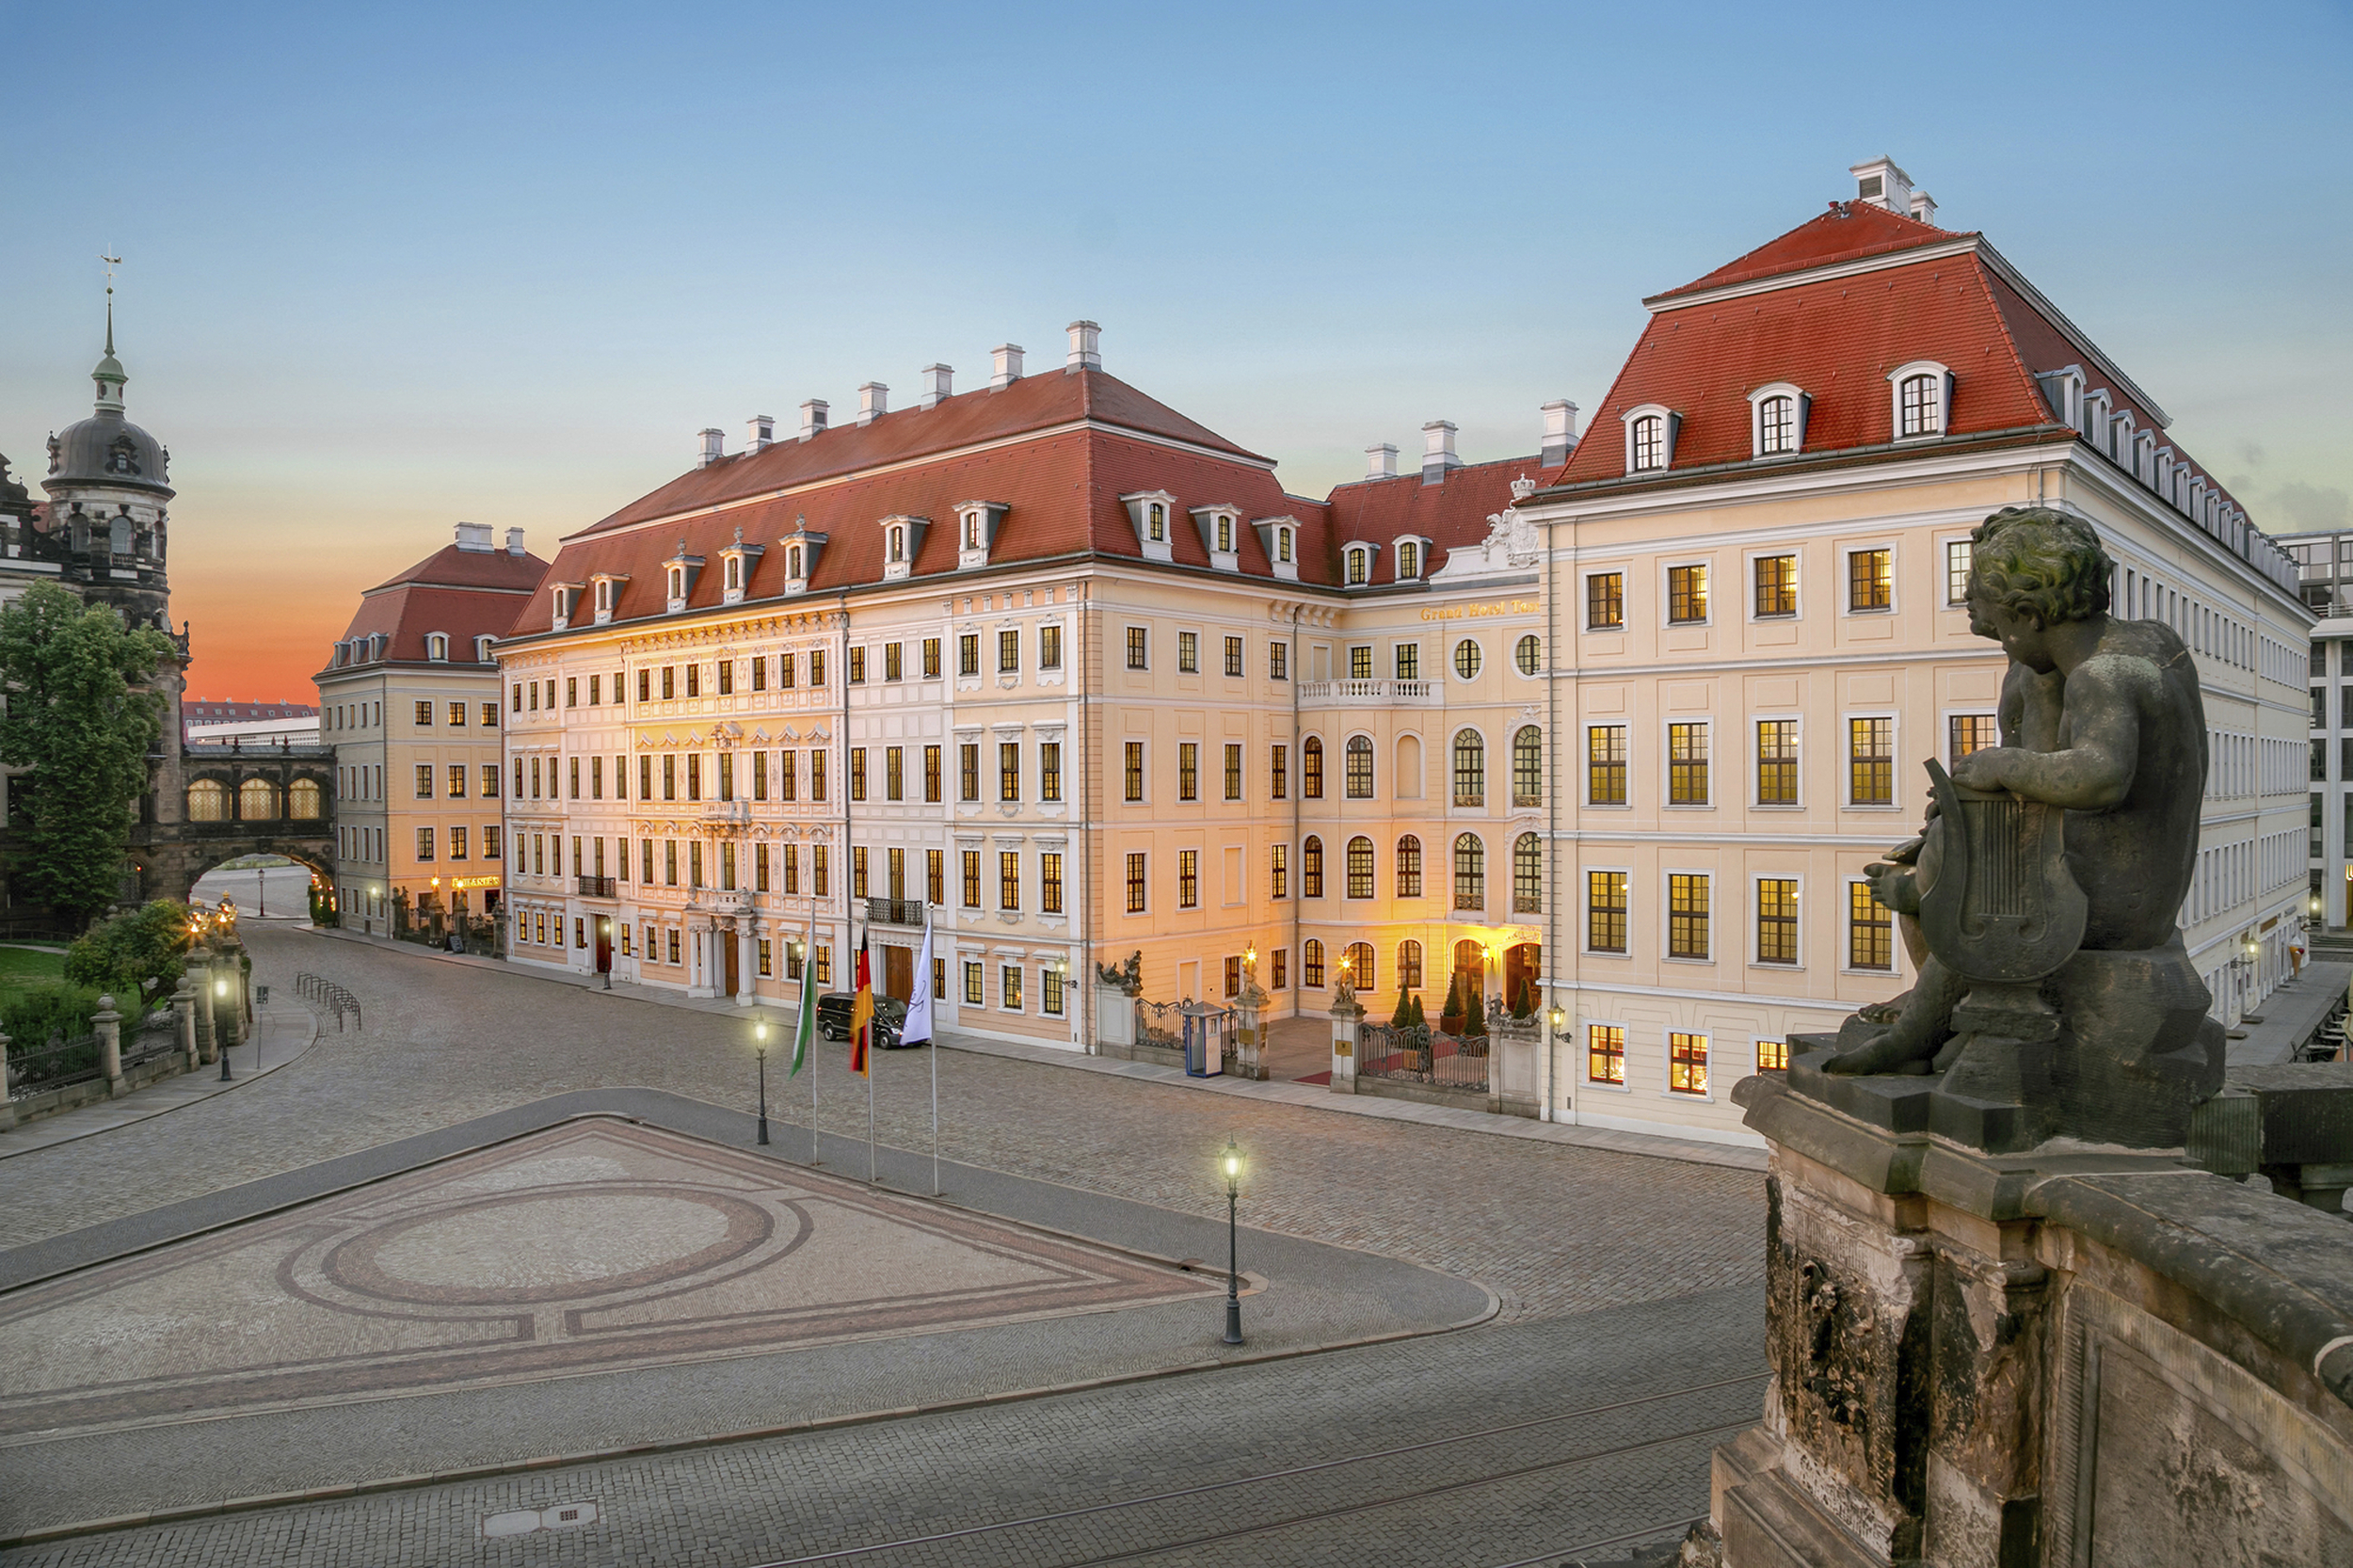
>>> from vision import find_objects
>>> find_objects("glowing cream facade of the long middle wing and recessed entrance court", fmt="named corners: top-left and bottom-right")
top-left (502, 518), bottom-right (1544, 1050)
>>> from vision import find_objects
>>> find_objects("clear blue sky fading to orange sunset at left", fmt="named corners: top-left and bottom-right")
top-left (0, 0), bottom-right (2353, 701)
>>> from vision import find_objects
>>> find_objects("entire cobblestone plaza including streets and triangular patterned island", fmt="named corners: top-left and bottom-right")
top-left (0, 930), bottom-right (1763, 1563)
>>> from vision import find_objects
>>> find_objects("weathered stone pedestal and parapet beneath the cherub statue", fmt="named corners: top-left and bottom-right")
top-left (1711, 1041), bottom-right (2353, 1568)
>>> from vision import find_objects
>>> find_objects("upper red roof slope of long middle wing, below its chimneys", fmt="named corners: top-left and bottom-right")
top-left (586, 370), bottom-right (1266, 532)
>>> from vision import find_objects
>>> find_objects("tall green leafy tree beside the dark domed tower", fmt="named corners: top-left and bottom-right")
top-left (0, 582), bottom-right (172, 925)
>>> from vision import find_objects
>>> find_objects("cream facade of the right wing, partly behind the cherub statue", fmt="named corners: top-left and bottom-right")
top-left (1525, 438), bottom-right (2311, 1140)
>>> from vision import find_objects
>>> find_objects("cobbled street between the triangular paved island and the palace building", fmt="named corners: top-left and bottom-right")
top-left (0, 928), bottom-right (1763, 1320)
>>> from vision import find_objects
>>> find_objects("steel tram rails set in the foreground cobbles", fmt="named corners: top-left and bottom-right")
top-left (758, 1372), bottom-right (1765, 1568)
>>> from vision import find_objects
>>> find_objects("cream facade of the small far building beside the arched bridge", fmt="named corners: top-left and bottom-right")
top-left (315, 662), bottom-right (506, 937)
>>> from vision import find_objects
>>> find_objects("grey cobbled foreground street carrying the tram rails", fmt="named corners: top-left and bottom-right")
top-left (0, 1288), bottom-right (1765, 1568)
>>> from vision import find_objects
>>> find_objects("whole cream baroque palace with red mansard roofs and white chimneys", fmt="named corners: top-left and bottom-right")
top-left (497, 160), bottom-right (2313, 1142)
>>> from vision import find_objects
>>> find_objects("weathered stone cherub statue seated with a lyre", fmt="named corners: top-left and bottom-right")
top-left (1821, 506), bottom-right (2221, 1144)
